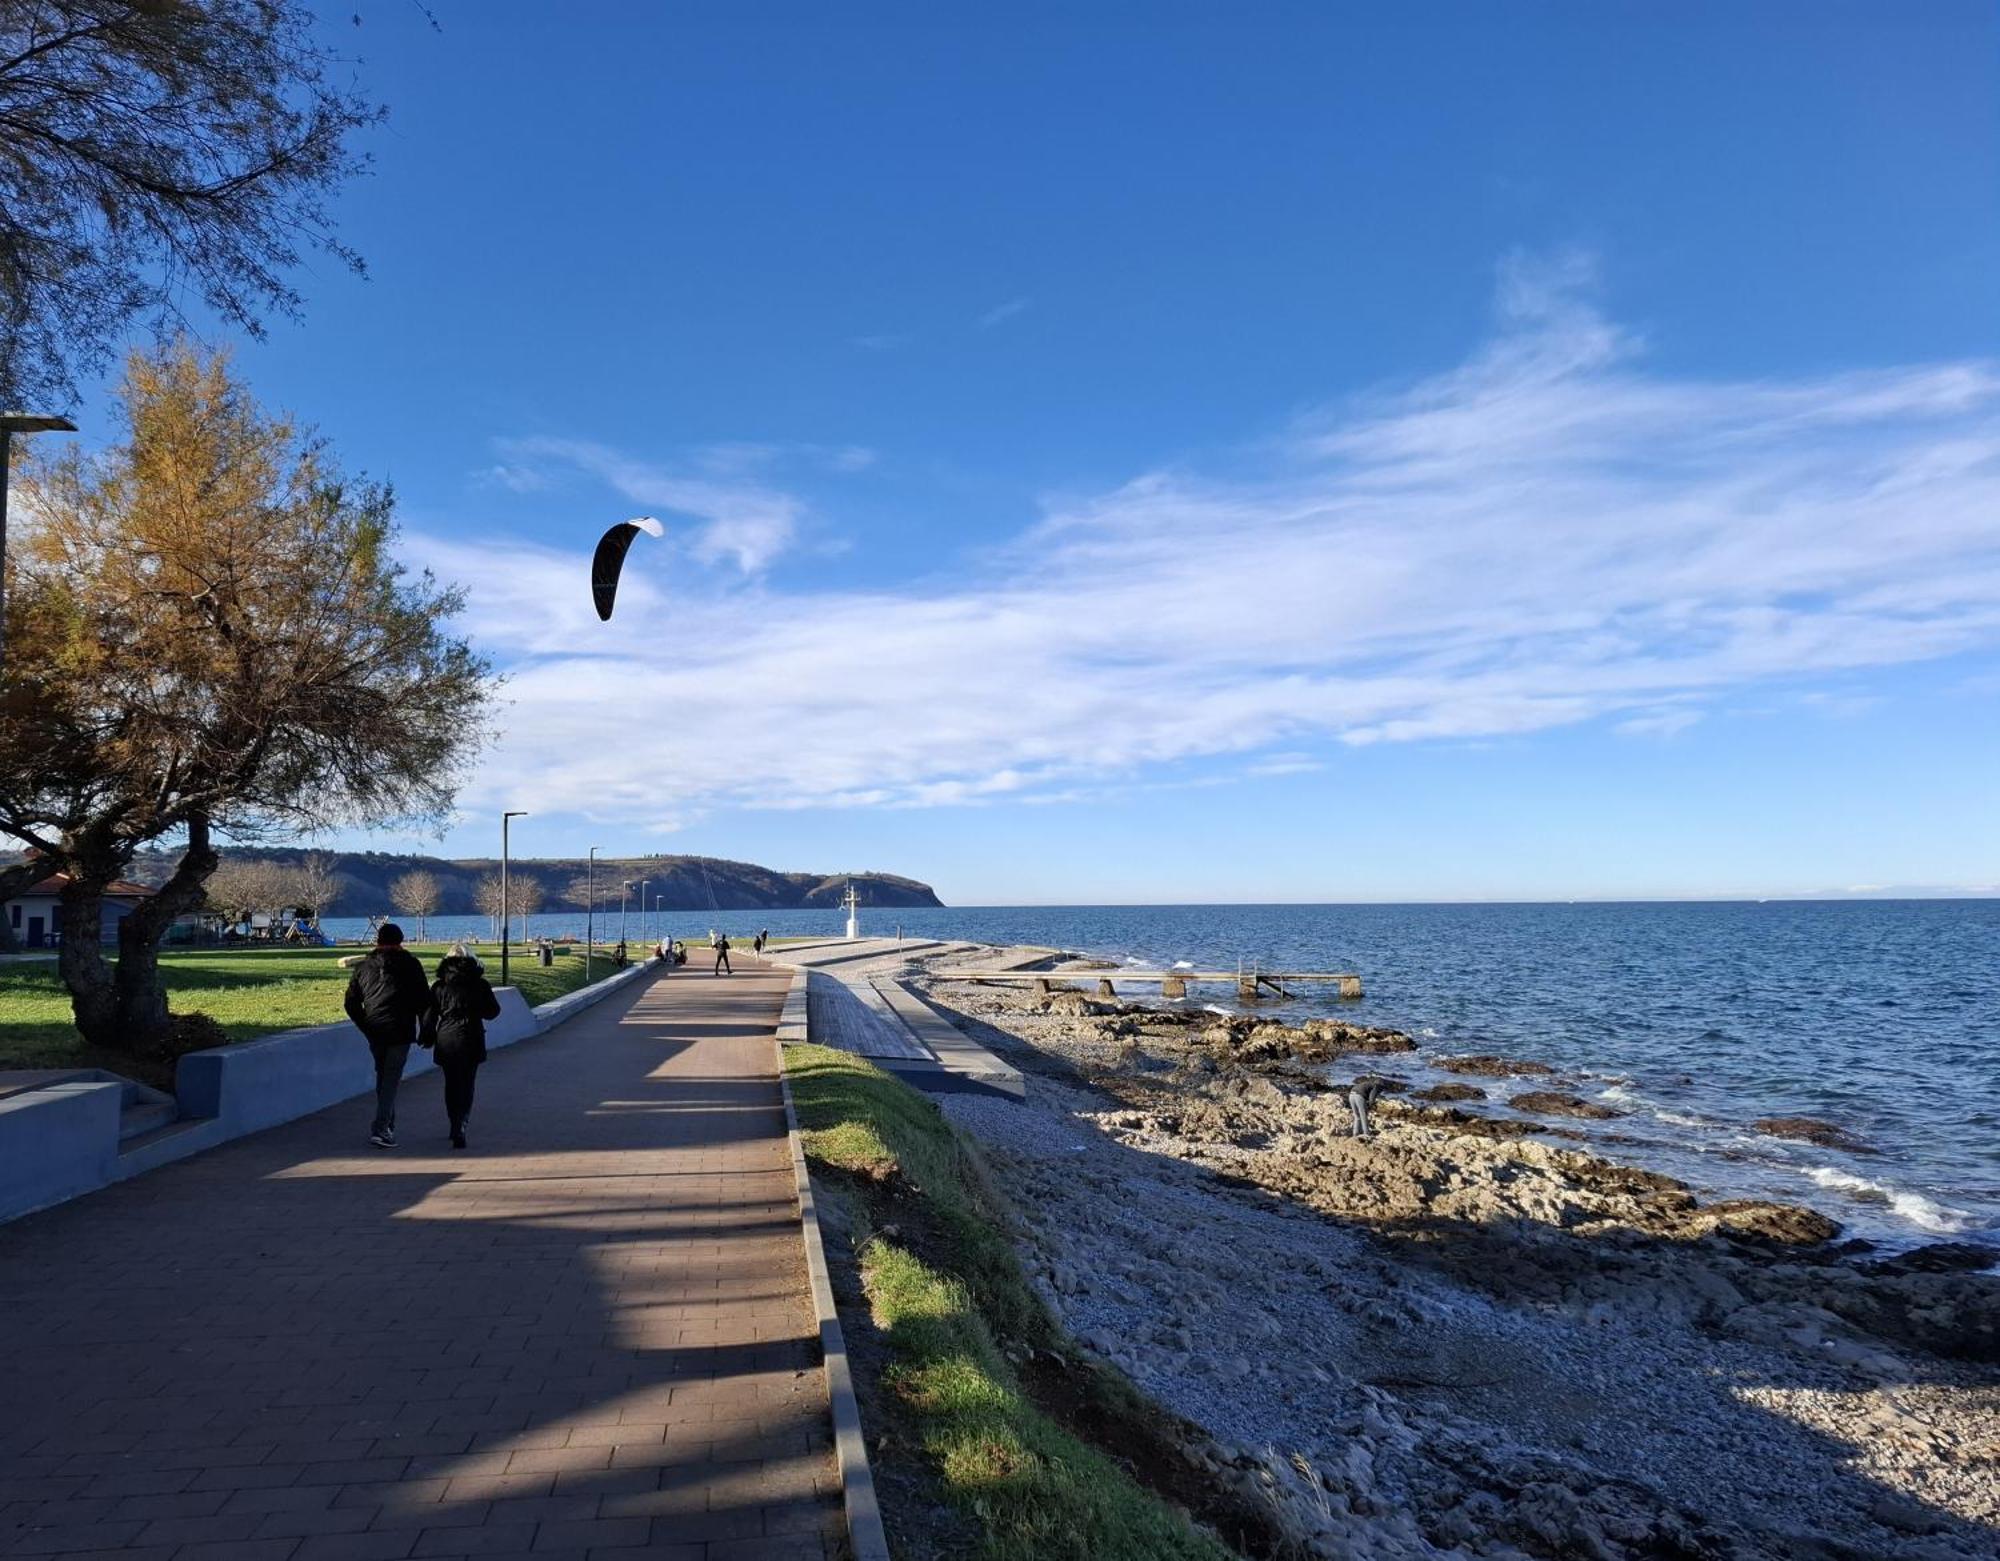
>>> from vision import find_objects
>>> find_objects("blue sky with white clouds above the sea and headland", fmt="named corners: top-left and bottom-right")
top-left (62, 0), bottom-right (2000, 903)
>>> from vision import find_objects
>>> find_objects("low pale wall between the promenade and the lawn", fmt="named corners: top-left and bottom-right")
top-left (0, 965), bottom-right (650, 1221)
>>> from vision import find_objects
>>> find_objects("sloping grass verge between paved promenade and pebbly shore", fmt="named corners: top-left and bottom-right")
top-left (784, 1047), bottom-right (1264, 1561)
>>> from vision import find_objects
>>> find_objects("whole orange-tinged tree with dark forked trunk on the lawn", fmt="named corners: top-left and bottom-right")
top-left (0, 342), bottom-right (490, 1045)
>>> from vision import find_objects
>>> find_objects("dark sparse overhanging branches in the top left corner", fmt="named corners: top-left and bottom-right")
top-left (0, 0), bottom-right (382, 406)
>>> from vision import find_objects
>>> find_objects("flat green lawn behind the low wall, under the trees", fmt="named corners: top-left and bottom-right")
top-left (0, 943), bottom-right (632, 1085)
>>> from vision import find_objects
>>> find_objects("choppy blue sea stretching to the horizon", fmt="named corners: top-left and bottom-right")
top-left (328, 899), bottom-right (2000, 1249)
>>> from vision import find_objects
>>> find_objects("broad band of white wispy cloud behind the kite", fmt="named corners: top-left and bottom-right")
top-left (430, 258), bottom-right (2000, 819)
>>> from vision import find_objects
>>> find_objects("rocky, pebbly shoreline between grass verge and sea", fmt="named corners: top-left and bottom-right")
top-left (926, 969), bottom-right (2000, 1561)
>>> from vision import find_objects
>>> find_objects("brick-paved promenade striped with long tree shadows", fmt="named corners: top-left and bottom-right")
top-left (0, 955), bottom-right (844, 1561)
